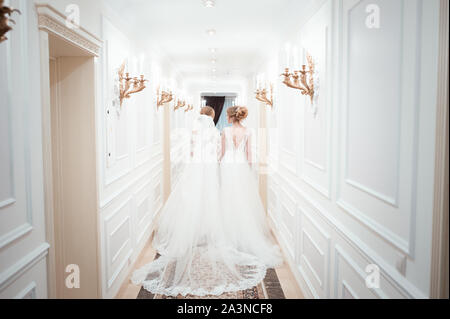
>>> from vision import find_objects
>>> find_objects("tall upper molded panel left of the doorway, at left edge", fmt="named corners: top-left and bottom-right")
top-left (0, 0), bottom-right (33, 249)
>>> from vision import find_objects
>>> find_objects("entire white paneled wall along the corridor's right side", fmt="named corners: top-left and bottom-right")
top-left (266, 0), bottom-right (439, 298)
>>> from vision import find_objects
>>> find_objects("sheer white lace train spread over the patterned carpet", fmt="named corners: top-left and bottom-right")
top-left (132, 247), bottom-right (267, 297)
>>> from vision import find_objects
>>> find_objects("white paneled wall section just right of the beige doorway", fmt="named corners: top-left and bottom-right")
top-left (98, 17), bottom-right (163, 298)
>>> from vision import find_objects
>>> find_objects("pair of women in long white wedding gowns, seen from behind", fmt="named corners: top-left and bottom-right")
top-left (132, 107), bottom-right (282, 297)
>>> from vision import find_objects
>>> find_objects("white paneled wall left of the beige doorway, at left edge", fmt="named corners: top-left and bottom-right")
top-left (0, 0), bottom-right (49, 298)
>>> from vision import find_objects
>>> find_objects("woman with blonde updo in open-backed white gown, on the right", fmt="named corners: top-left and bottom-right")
top-left (220, 106), bottom-right (282, 268)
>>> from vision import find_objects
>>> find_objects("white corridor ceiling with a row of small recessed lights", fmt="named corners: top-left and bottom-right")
top-left (107, 0), bottom-right (317, 86)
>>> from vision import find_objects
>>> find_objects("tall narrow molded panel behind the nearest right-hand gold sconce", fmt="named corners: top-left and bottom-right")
top-left (300, 1), bottom-right (335, 199)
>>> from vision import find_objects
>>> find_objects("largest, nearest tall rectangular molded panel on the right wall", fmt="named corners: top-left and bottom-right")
top-left (337, 0), bottom-right (422, 257)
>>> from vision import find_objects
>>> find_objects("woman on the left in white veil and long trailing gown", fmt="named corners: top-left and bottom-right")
top-left (132, 108), bottom-right (284, 296)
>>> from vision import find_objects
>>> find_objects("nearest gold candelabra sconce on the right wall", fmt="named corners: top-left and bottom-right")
top-left (281, 55), bottom-right (316, 103)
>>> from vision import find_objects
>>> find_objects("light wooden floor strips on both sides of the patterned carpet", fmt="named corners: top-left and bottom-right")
top-left (116, 235), bottom-right (304, 299)
